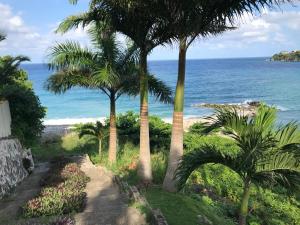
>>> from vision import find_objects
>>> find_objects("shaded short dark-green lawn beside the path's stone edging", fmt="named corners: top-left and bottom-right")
top-left (144, 188), bottom-right (235, 225)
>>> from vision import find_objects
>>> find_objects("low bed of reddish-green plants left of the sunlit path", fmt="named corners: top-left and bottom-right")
top-left (22, 159), bottom-right (89, 218)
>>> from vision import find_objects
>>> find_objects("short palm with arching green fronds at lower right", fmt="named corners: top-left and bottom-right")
top-left (176, 105), bottom-right (300, 225)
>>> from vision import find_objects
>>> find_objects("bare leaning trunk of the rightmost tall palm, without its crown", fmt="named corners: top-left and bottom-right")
top-left (163, 38), bottom-right (187, 192)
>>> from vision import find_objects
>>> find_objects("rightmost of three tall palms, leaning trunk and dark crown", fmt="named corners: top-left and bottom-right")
top-left (163, 0), bottom-right (292, 192)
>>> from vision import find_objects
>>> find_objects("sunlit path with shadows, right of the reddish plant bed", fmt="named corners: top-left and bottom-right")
top-left (75, 157), bottom-right (146, 225)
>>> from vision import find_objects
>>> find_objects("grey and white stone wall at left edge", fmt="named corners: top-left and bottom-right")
top-left (0, 139), bottom-right (33, 199)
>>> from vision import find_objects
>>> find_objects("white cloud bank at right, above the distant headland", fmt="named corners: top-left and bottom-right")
top-left (204, 10), bottom-right (300, 49)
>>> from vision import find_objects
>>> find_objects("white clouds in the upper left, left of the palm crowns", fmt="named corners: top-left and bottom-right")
top-left (0, 3), bottom-right (86, 62)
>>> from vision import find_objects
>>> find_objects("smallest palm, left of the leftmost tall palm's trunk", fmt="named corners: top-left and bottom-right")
top-left (75, 121), bottom-right (108, 159)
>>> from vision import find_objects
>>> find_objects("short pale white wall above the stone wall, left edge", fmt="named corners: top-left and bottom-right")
top-left (0, 100), bottom-right (11, 138)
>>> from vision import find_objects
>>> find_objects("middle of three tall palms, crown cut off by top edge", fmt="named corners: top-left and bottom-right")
top-left (58, 0), bottom-right (175, 182)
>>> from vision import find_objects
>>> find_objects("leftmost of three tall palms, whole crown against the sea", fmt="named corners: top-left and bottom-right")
top-left (46, 23), bottom-right (172, 163)
